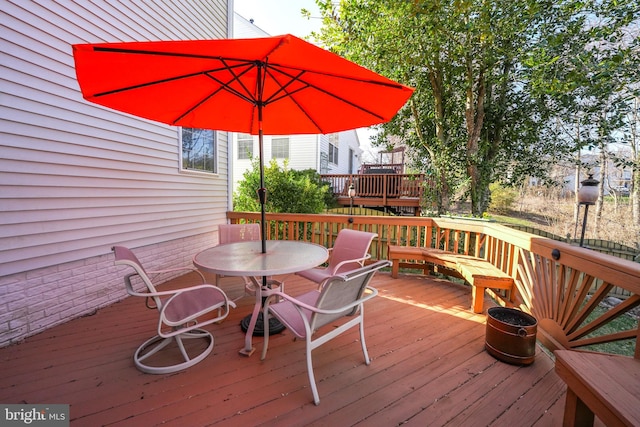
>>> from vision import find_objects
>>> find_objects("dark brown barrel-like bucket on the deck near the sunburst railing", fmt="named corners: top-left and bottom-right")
top-left (485, 307), bottom-right (538, 365)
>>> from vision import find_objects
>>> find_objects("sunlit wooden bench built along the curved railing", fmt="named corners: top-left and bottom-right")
top-left (389, 245), bottom-right (514, 313)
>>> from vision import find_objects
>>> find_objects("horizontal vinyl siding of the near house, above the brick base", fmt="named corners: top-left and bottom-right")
top-left (0, 0), bottom-right (228, 274)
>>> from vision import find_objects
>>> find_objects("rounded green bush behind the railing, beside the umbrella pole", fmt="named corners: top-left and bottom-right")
top-left (233, 159), bottom-right (331, 213)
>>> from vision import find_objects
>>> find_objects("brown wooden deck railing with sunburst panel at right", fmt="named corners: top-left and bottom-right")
top-left (227, 212), bottom-right (640, 354)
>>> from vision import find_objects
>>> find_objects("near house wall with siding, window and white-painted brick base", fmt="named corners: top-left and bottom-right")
top-left (0, 0), bottom-right (233, 347)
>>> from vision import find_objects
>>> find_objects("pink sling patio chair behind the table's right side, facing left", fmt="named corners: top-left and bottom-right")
top-left (296, 228), bottom-right (378, 284)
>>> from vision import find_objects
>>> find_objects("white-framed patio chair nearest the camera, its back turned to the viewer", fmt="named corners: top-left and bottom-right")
top-left (262, 260), bottom-right (391, 405)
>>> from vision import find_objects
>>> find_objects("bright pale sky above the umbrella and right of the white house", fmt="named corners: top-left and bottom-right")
top-left (234, 0), bottom-right (377, 162)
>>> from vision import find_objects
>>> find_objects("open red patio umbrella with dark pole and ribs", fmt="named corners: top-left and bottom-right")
top-left (73, 35), bottom-right (413, 252)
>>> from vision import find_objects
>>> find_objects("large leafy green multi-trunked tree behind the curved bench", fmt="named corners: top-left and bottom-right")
top-left (314, 0), bottom-right (633, 216)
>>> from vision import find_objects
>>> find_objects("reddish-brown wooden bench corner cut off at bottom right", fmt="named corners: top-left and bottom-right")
top-left (554, 352), bottom-right (640, 427)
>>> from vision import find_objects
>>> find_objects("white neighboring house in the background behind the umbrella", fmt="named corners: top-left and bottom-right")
top-left (232, 13), bottom-right (362, 194)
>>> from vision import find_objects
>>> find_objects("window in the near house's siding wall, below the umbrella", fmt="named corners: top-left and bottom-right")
top-left (180, 128), bottom-right (218, 173)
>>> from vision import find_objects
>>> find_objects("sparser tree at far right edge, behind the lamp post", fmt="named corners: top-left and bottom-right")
top-left (531, 0), bottom-right (640, 239)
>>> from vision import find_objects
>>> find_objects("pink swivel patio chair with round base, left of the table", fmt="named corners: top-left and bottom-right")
top-left (112, 246), bottom-right (235, 374)
